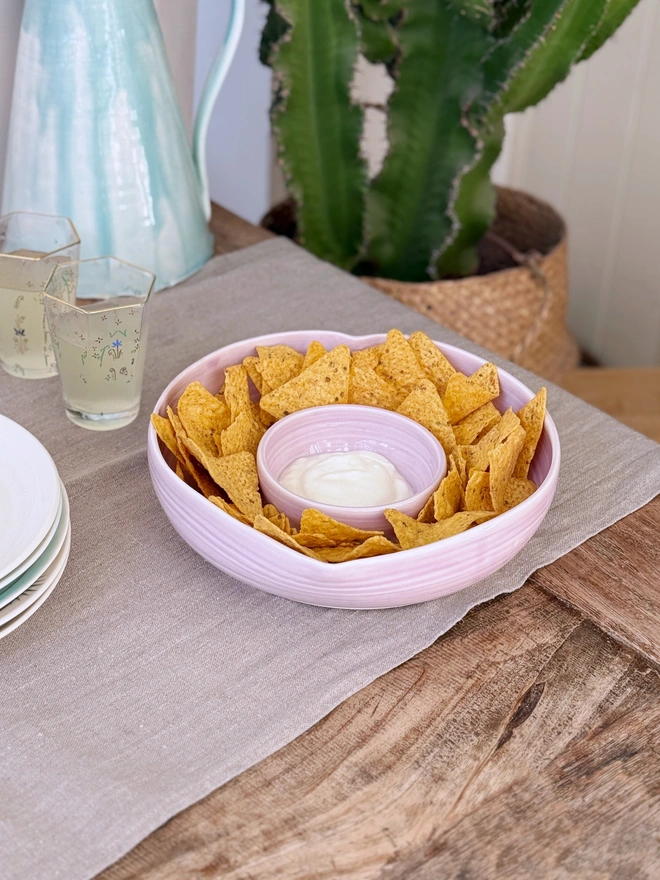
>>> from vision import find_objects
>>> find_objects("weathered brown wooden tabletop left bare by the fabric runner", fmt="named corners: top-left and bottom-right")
top-left (99, 208), bottom-right (660, 880)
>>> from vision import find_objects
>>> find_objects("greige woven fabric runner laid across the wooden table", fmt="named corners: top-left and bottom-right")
top-left (0, 240), bottom-right (660, 880)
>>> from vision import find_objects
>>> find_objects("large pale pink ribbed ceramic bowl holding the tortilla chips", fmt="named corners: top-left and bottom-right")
top-left (148, 330), bottom-right (560, 608)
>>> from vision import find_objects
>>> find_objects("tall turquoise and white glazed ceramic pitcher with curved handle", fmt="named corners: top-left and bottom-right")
top-left (0, 0), bottom-right (245, 288)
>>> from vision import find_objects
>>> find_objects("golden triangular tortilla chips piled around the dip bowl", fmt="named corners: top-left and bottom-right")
top-left (151, 330), bottom-right (546, 562)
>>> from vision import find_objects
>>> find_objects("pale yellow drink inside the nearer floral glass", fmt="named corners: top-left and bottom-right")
top-left (51, 296), bottom-right (146, 431)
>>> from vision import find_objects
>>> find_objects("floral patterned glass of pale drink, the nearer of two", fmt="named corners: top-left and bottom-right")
top-left (44, 257), bottom-right (155, 431)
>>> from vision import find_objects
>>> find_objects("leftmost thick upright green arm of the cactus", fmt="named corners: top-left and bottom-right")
top-left (271, 0), bottom-right (367, 269)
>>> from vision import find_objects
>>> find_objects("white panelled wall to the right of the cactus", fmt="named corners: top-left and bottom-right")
top-left (498, 0), bottom-right (660, 366)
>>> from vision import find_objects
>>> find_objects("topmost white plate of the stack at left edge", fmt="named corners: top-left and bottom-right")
top-left (0, 416), bottom-right (60, 577)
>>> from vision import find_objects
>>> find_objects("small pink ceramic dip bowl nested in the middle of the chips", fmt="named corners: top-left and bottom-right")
top-left (257, 404), bottom-right (447, 535)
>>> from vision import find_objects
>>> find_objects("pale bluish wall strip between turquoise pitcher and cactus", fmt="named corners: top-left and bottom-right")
top-left (195, 0), bottom-right (271, 223)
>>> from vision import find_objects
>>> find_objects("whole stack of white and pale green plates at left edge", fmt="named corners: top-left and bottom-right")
top-left (0, 416), bottom-right (71, 639)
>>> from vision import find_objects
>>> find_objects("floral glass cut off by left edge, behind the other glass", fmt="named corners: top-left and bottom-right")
top-left (0, 212), bottom-right (80, 379)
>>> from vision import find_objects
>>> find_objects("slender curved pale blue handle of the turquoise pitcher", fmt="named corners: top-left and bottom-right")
top-left (193, 0), bottom-right (245, 220)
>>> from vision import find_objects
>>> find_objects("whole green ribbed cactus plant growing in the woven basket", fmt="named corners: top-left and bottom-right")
top-left (261, 0), bottom-right (638, 281)
